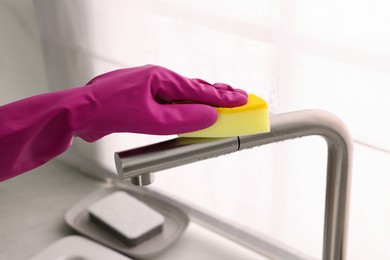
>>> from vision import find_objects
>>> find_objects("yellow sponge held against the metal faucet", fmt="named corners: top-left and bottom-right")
top-left (179, 94), bottom-right (270, 138)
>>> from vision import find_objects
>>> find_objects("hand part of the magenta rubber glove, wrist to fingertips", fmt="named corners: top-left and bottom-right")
top-left (76, 65), bottom-right (247, 141)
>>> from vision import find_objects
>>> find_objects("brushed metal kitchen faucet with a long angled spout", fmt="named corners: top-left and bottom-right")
top-left (115, 110), bottom-right (353, 260)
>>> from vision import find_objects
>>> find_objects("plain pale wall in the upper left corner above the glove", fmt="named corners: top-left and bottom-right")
top-left (0, 0), bottom-right (48, 104)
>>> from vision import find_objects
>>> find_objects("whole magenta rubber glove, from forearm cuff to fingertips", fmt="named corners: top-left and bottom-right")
top-left (0, 65), bottom-right (247, 180)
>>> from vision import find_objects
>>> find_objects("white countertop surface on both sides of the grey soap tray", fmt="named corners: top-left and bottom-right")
top-left (0, 160), bottom-right (266, 260)
